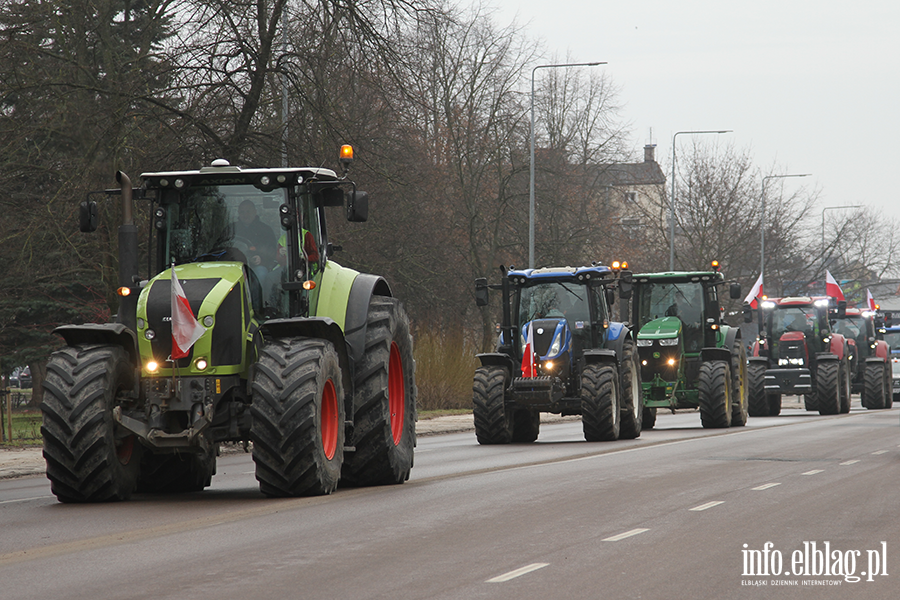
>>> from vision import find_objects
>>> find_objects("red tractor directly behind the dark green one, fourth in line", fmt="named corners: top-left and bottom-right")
top-left (744, 296), bottom-right (852, 416)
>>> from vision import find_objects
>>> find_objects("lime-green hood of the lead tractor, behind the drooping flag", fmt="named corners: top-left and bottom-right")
top-left (137, 262), bottom-right (257, 376)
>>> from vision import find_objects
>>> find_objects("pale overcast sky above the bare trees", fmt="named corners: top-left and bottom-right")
top-left (485, 0), bottom-right (900, 220)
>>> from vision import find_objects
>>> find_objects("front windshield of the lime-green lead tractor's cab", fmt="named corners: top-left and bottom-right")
top-left (161, 185), bottom-right (285, 273)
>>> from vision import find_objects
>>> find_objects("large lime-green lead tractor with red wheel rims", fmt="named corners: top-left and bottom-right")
top-left (41, 146), bottom-right (417, 502)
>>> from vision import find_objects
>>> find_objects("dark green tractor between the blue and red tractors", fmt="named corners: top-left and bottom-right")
top-left (632, 262), bottom-right (747, 429)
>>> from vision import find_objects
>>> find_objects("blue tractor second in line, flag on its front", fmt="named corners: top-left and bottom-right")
top-left (473, 263), bottom-right (643, 444)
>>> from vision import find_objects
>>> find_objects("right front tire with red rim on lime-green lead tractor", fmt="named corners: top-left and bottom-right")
top-left (250, 338), bottom-right (344, 496)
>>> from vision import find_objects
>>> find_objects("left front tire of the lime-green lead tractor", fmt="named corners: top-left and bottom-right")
top-left (41, 345), bottom-right (142, 502)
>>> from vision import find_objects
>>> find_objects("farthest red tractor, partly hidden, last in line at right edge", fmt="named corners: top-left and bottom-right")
top-left (834, 308), bottom-right (893, 410)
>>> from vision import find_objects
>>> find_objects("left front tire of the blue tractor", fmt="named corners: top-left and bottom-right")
top-left (472, 367), bottom-right (513, 445)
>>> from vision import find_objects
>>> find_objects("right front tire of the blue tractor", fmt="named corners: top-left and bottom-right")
top-left (581, 364), bottom-right (621, 442)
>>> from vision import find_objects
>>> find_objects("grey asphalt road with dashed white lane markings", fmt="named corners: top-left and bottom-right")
top-left (0, 403), bottom-right (900, 600)
